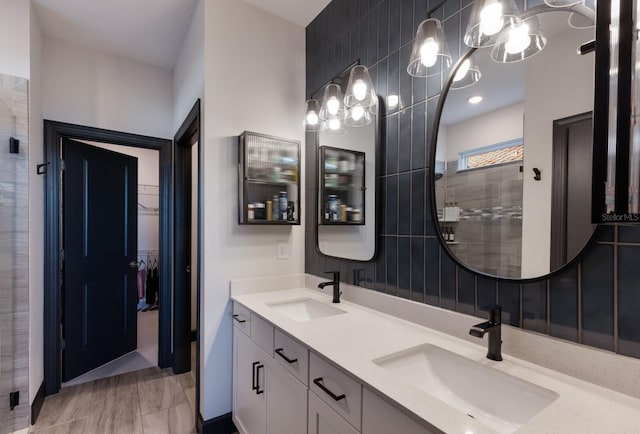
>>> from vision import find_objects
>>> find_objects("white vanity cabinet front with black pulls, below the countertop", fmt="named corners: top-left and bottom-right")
top-left (233, 303), bottom-right (439, 434)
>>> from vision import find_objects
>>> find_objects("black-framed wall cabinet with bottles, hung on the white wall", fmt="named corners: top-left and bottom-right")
top-left (238, 131), bottom-right (301, 226)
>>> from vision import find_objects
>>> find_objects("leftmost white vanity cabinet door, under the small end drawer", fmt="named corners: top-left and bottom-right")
top-left (233, 330), bottom-right (267, 434)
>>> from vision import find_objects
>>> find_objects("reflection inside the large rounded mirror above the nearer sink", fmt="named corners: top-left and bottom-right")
top-left (434, 6), bottom-right (595, 279)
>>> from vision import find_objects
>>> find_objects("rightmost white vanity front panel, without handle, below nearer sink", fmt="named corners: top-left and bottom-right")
top-left (362, 388), bottom-right (440, 434)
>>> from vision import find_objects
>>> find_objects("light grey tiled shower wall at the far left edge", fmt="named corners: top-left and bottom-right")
top-left (0, 74), bottom-right (29, 433)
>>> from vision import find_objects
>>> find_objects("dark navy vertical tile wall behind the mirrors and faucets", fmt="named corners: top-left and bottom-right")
top-left (305, 0), bottom-right (640, 358)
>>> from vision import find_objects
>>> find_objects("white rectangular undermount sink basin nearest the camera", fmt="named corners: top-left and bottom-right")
top-left (373, 344), bottom-right (558, 433)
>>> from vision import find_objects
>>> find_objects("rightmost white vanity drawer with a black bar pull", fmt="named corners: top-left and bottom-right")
top-left (309, 352), bottom-right (362, 431)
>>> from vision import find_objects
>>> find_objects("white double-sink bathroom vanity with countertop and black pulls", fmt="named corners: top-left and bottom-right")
top-left (231, 276), bottom-right (640, 434)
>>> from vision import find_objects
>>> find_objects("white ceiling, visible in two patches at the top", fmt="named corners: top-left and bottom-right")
top-left (32, 0), bottom-right (330, 69)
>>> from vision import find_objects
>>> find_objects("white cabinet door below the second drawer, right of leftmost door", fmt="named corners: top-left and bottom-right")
top-left (266, 361), bottom-right (307, 434)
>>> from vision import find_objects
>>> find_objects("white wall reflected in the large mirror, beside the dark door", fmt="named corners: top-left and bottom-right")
top-left (522, 25), bottom-right (595, 277)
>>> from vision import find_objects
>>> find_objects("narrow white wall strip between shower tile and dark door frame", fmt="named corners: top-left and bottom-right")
top-left (28, 2), bottom-right (44, 404)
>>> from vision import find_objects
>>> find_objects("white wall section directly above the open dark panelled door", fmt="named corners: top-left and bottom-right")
top-left (43, 37), bottom-right (174, 138)
